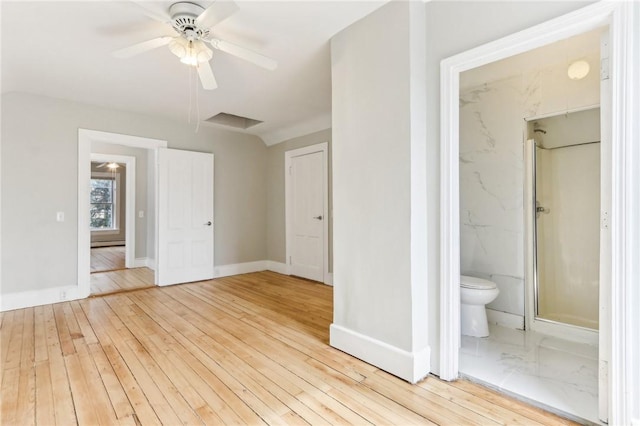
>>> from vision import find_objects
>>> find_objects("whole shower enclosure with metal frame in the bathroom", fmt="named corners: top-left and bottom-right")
top-left (525, 108), bottom-right (601, 338)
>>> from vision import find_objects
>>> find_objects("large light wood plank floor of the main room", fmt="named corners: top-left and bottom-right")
top-left (0, 272), bottom-right (570, 426)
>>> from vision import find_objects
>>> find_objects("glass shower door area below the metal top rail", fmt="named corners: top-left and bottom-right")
top-left (535, 142), bottom-right (600, 330)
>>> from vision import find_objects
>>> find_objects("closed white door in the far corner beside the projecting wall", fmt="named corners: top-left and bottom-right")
top-left (289, 152), bottom-right (326, 282)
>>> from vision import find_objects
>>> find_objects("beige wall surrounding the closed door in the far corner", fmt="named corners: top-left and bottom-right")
top-left (267, 129), bottom-right (333, 272)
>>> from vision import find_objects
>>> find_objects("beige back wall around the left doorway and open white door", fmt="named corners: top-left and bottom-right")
top-left (1, 93), bottom-right (267, 293)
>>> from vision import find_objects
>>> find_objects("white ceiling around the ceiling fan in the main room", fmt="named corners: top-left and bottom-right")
top-left (0, 0), bottom-right (388, 145)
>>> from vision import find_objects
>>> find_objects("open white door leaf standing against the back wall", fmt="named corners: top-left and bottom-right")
top-left (157, 149), bottom-right (213, 285)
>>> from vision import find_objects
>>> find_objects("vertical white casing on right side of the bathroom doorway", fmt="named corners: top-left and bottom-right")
top-left (609, 2), bottom-right (640, 424)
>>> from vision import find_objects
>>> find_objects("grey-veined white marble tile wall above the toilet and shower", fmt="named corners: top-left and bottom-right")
top-left (460, 64), bottom-right (600, 316)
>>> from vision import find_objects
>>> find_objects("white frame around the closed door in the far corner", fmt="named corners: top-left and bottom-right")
top-left (284, 142), bottom-right (333, 285)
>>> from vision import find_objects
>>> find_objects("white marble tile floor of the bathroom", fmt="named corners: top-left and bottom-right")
top-left (460, 325), bottom-right (601, 424)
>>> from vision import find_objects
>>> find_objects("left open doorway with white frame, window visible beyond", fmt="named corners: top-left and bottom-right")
top-left (78, 129), bottom-right (166, 297)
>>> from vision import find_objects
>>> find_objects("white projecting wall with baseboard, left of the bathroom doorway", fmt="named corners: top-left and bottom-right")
top-left (331, 2), bottom-right (429, 381)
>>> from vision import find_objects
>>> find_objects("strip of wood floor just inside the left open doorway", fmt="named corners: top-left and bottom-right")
top-left (91, 268), bottom-right (155, 296)
